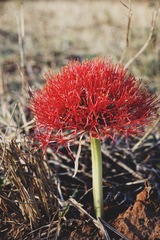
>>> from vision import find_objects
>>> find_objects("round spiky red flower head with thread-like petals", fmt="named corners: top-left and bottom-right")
top-left (31, 59), bottom-right (159, 148)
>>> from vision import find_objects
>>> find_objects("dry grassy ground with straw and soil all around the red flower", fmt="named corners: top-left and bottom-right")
top-left (0, 0), bottom-right (160, 240)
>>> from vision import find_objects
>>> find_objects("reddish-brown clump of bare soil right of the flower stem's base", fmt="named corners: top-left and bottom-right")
top-left (114, 187), bottom-right (160, 240)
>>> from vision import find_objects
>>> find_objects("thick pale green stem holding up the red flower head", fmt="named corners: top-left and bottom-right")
top-left (91, 137), bottom-right (103, 218)
